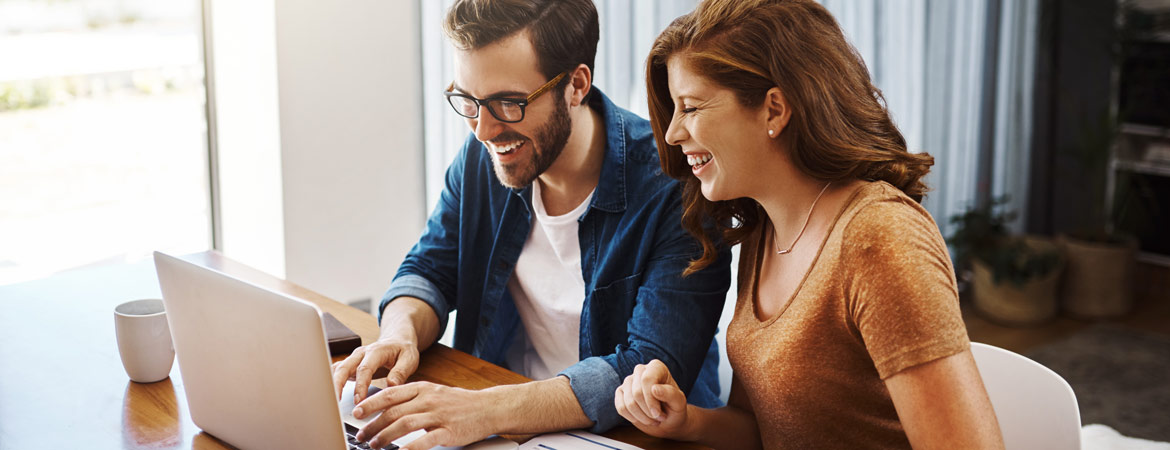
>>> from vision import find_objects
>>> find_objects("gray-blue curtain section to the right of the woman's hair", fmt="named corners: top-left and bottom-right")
top-left (824, 0), bottom-right (1039, 236)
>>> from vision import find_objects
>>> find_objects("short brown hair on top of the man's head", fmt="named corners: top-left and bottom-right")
top-left (442, 0), bottom-right (599, 92)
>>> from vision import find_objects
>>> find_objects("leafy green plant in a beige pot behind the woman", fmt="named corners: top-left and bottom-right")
top-left (947, 198), bottom-right (1064, 326)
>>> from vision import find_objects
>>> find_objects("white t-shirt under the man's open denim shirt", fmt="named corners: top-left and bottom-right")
top-left (507, 181), bottom-right (593, 380)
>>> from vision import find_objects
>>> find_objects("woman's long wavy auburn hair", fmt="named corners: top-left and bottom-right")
top-left (646, 0), bottom-right (934, 276)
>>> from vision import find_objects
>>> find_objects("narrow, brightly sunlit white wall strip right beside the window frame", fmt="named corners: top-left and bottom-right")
top-left (208, 0), bottom-right (284, 277)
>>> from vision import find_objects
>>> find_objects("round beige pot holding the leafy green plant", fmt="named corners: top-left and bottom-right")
top-left (971, 237), bottom-right (1061, 326)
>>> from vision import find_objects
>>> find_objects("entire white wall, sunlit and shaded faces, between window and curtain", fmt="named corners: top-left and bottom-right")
top-left (211, 0), bottom-right (425, 304)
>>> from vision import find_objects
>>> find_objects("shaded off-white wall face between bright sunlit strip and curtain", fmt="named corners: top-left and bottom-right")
top-left (276, 0), bottom-right (425, 308)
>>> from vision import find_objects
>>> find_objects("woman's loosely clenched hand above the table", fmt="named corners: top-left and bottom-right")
top-left (613, 360), bottom-right (689, 441)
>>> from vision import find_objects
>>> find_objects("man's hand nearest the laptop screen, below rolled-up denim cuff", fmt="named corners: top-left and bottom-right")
top-left (333, 337), bottom-right (419, 403)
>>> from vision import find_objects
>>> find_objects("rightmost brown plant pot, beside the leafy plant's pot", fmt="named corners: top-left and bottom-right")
top-left (1059, 236), bottom-right (1137, 319)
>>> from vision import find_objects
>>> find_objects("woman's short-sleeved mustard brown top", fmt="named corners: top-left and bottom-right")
top-left (728, 181), bottom-right (970, 449)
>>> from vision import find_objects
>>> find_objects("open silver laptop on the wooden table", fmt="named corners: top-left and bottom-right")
top-left (154, 251), bottom-right (516, 450)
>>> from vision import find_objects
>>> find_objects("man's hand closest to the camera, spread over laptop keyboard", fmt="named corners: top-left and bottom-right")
top-left (343, 381), bottom-right (502, 450)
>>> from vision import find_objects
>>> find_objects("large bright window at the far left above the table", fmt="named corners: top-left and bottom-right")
top-left (0, 0), bottom-right (212, 284)
